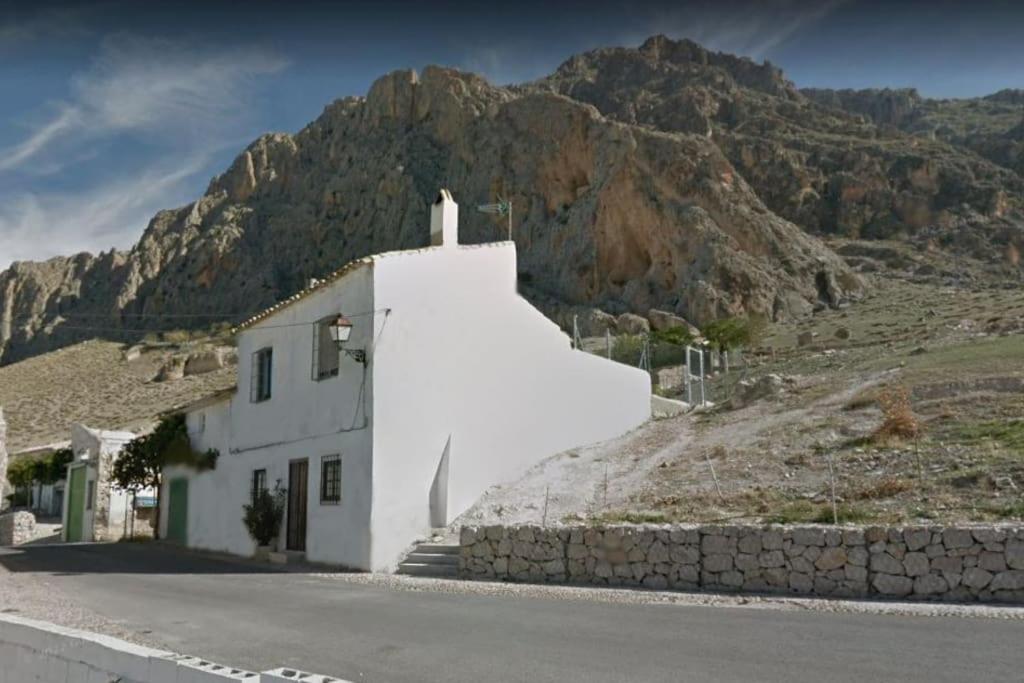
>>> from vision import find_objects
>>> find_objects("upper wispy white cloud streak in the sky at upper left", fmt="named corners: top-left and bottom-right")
top-left (0, 36), bottom-right (288, 171)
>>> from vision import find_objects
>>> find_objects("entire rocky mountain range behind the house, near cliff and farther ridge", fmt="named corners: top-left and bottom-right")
top-left (0, 37), bottom-right (1024, 362)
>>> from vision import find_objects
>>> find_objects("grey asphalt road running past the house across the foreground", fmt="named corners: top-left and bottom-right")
top-left (0, 545), bottom-right (1024, 683)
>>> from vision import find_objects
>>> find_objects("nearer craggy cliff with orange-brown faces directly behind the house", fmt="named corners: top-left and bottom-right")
top-left (0, 44), bottom-right (861, 362)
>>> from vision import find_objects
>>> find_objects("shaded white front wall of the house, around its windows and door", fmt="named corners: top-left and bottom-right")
top-left (161, 266), bottom-right (374, 568)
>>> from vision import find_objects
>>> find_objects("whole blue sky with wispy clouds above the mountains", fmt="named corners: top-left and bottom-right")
top-left (0, 0), bottom-right (1024, 269)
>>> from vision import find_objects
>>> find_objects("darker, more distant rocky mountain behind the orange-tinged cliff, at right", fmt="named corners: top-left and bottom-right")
top-left (538, 36), bottom-right (1024, 249)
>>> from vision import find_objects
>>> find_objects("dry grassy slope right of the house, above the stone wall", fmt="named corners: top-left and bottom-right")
top-left (452, 243), bottom-right (1024, 532)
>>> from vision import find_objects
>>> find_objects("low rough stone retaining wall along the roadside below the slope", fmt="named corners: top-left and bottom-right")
top-left (459, 525), bottom-right (1024, 602)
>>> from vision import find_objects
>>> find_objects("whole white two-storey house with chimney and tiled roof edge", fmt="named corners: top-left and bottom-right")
top-left (161, 190), bottom-right (650, 569)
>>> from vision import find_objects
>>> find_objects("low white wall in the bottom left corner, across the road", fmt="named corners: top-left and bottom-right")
top-left (0, 614), bottom-right (346, 683)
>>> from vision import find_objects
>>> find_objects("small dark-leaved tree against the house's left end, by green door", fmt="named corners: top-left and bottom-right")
top-left (113, 413), bottom-right (220, 538)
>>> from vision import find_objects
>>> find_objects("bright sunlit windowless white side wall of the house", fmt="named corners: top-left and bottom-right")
top-left (372, 243), bottom-right (650, 568)
